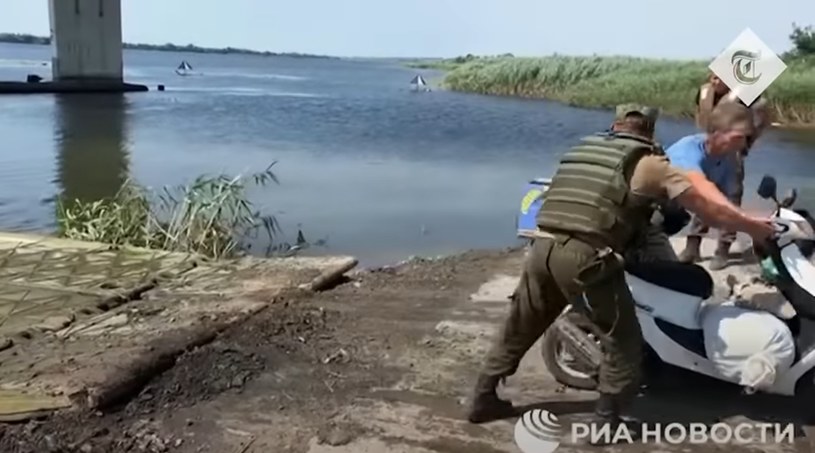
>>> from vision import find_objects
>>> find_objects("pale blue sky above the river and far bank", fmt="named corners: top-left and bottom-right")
top-left (0, 0), bottom-right (815, 59)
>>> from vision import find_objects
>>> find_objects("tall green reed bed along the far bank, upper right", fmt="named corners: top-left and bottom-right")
top-left (425, 55), bottom-right (815, 126)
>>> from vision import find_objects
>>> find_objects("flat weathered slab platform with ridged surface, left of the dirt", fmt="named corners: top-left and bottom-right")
top-left (0, 233), bottom-right (356, 421)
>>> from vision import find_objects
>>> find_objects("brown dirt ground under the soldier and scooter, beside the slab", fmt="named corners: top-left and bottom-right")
top-left (0, 238), bottom-right (815, 453)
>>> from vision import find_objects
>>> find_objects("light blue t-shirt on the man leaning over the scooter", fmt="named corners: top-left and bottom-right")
top-left (665, 134), bottom-right (736, 196)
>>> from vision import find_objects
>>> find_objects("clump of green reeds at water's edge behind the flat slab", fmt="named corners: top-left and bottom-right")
top-left (57, 165), bottom-right (279, 259)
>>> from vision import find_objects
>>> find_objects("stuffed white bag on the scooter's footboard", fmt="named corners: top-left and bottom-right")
top-left (702, 305), bottom-right (795, 391)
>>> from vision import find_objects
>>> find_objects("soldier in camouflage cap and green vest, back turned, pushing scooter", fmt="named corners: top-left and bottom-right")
top-left (468, 101), bottom-right (773, 442)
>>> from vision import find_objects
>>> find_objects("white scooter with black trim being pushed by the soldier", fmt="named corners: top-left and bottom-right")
top-left (518, 176), bottom-right (815, 395)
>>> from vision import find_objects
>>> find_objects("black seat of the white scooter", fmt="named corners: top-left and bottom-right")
top-left (625, 261), bottom-right (713, 299)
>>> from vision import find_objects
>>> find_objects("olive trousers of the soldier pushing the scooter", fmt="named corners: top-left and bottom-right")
top-left (483, 237), bottom-right (642, 398)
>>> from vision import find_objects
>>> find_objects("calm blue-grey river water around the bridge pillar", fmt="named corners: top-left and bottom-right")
top-left (0, 44), bottom-right (815, 265)
